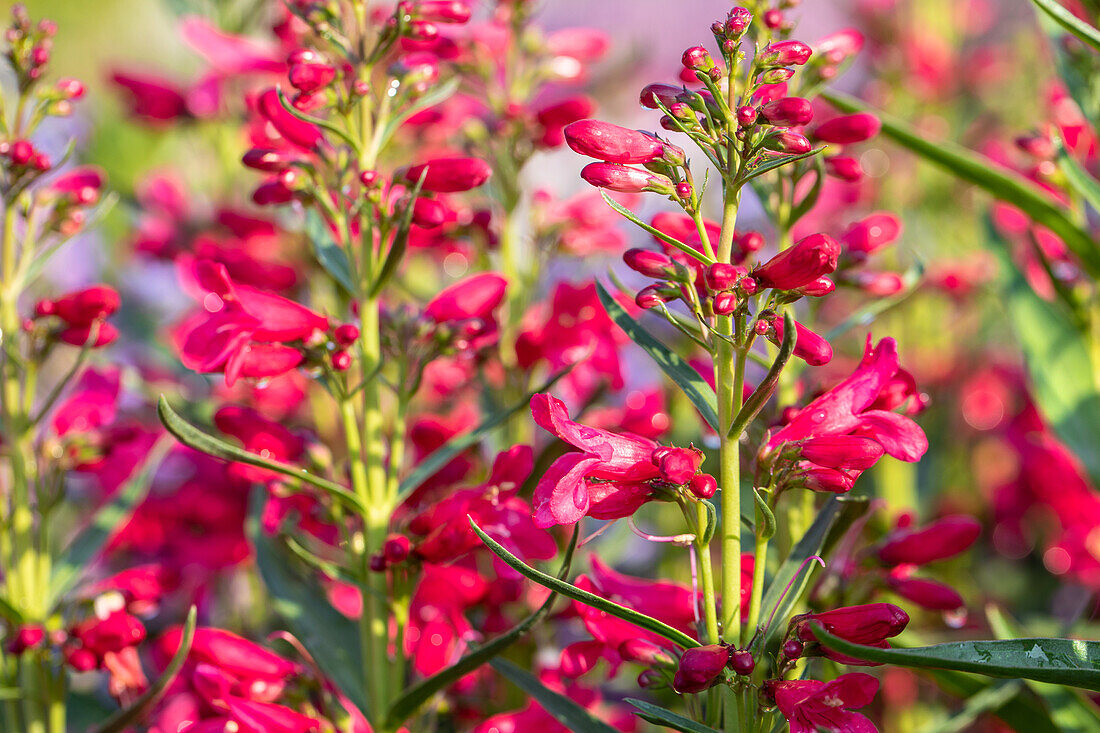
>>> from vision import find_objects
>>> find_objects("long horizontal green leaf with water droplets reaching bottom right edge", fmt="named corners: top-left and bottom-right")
top-left (812, 625), bottom-right (1100, 690)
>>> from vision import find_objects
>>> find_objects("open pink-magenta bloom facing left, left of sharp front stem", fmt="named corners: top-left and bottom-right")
top-left (531, 394), bottom-right (661, 527)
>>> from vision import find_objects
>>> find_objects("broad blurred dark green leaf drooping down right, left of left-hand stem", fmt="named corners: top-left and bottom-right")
top-left (245, 486), bottom-right (367, 715)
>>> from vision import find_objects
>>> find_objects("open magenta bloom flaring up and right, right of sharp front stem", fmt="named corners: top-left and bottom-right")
top-left (767, 337), bottom-right (928, 462)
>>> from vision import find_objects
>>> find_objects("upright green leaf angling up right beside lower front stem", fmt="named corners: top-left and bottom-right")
top-left (750, 496), bottom-right (866, 655)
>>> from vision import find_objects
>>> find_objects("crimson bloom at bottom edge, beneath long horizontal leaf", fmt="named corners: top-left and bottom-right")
top-left (766, 672), bottom-right (879, 733)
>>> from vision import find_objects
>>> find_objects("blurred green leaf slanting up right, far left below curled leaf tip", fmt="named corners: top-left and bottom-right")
top-left (46, 438), bottom-right (172, 608)
